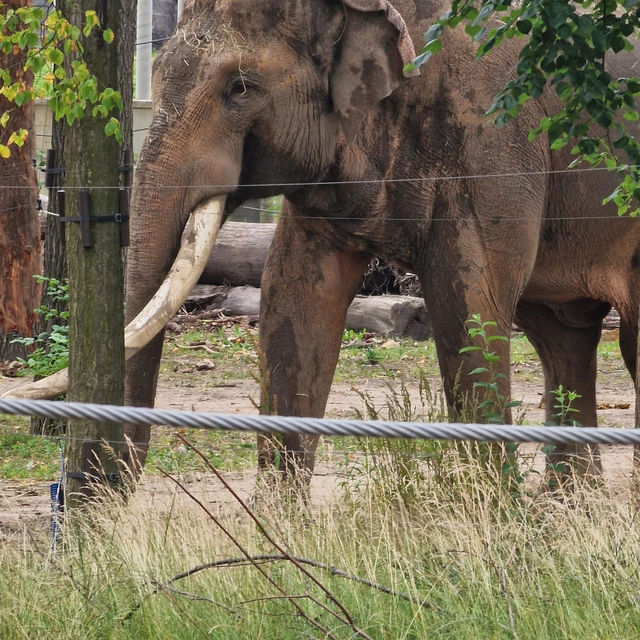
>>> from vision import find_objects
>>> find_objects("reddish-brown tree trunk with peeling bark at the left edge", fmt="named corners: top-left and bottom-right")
top-left (0, 0), bottom-right (41, 360)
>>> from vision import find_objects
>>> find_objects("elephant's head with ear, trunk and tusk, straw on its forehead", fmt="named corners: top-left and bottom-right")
top-left (2, 0), bottom-right (414, 404)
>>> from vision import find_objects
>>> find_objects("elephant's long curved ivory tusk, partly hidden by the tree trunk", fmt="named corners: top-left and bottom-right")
top-left (0, 196), bottom-right (225, 399)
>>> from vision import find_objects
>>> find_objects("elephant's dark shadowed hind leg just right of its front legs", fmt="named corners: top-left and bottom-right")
top-left (516, 301), bottom-right (609, 475)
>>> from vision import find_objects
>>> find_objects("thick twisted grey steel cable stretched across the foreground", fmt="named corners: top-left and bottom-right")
top-left (0, 398), bottom-right (640, 445)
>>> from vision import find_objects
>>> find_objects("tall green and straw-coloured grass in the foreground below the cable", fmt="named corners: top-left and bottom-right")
top-left (0, 454), bottom-right (640, 640)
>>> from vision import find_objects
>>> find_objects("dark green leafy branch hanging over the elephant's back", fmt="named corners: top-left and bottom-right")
top-left (408, 0), bottom-right (640, 216)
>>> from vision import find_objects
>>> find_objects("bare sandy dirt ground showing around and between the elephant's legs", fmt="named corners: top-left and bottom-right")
top-left (0, 328), bottom-right (634, 544)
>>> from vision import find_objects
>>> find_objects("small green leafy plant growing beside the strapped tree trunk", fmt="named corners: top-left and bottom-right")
top-left (12, 276), bottom-right (69, 378)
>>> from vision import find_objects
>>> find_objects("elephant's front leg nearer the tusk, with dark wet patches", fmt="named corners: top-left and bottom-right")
top-left (258, 213), bottom-right (369, 479)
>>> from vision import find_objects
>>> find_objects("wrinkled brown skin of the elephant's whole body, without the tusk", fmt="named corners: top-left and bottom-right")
top-left (127, 0), bottom-right (640, 480)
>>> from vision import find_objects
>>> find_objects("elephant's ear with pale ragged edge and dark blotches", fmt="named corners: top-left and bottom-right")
top-left (331, 0), bottom-right (418, 139)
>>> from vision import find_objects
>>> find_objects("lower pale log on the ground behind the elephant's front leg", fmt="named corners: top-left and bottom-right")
top-left (186, 285), bottom-right (430, 340)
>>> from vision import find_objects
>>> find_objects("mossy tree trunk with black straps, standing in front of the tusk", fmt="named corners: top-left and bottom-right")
top-left (65, 0), bottom-right (133, 506)
